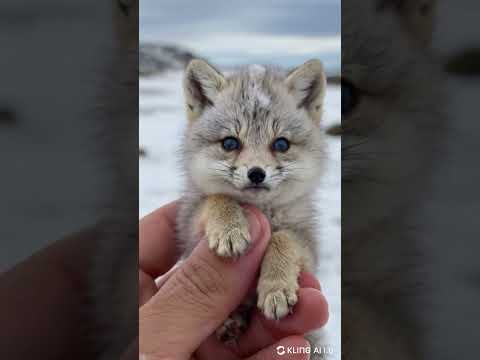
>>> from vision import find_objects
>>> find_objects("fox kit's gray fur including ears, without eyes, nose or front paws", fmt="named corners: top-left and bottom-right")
top-left (177, 60), bottom-right (326, 341)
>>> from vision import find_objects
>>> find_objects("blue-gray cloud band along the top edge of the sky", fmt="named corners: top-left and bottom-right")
top-left (140, 0), bottom-right (341, 37)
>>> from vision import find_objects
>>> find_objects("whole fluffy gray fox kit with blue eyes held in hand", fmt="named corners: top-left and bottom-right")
top-left (177, 60), bottom-right (326, 341)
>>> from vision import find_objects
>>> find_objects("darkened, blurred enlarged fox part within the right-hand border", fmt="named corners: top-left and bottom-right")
top-left (342, 0), bottom-right (446, 359)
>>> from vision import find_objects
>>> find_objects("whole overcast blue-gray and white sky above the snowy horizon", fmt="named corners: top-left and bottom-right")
top-left (140, 0), bottom-right (341, 70)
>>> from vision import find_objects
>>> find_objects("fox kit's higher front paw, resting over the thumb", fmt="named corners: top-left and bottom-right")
top-left (205, 215), bottom-right (251, 257)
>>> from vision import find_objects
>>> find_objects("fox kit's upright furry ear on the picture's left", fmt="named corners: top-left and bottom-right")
top-left (183, 59), bottom-right (226, 121)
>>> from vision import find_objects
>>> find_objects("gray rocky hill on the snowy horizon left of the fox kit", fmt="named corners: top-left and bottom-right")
top-left (138, 43), bottom-right (195, 76)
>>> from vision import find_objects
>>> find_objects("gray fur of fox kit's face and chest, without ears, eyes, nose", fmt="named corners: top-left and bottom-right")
top-left (177, 65), bottom-right (324, 270)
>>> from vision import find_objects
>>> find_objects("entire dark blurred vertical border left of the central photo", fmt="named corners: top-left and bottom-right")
top-left (0, 0), bottom-right (138, 359)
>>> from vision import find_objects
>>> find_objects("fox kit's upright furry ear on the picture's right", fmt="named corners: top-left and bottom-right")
top-left (285, 60), bottom-right (327, 123)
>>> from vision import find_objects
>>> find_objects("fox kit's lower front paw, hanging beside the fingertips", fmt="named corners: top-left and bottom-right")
top-left (257, 281), bottom-right (298, 320)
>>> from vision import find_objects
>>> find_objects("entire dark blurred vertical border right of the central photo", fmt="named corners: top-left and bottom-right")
top-left (339, 0), bottom-right (480, 360)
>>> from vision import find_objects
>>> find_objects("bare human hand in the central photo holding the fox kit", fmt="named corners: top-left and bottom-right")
top-left (139, 203), bottom-right (328, 360)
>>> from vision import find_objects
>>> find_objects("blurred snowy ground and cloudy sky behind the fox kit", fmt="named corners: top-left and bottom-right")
top-left (139, 0), bottom-right (341, 359)
